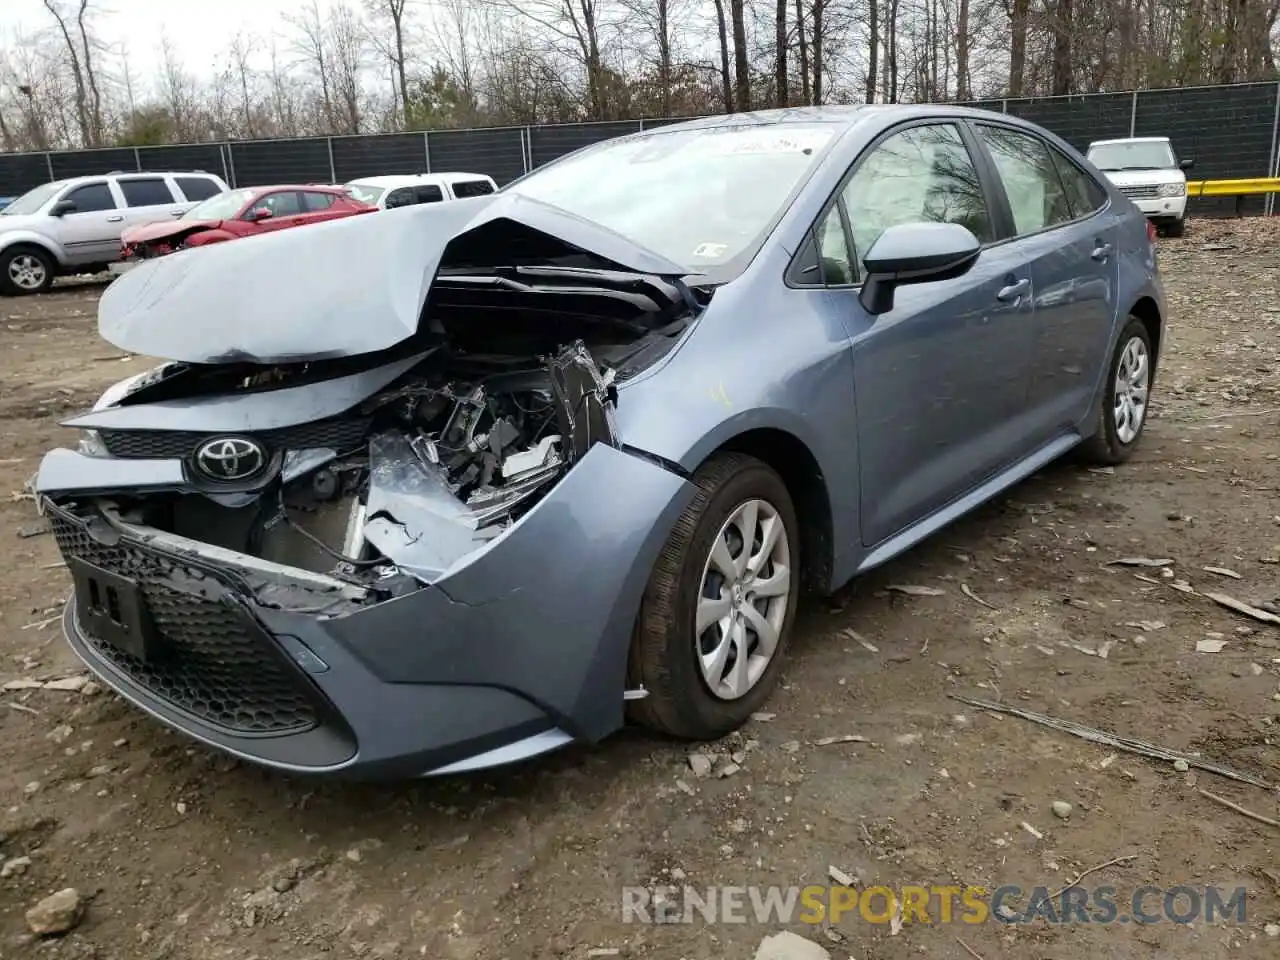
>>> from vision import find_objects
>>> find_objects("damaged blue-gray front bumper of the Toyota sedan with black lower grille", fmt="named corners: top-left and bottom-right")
top-left (41, 444), bottom-right (692, 777)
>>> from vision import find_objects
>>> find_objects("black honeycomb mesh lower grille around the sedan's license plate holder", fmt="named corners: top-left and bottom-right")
top-left (49, 507), bottom-right (319, 735)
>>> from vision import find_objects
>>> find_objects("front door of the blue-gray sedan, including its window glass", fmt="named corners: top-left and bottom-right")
top-left (820, 122), bottom-right (1034, 547)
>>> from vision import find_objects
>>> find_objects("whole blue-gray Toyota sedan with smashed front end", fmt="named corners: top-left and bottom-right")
top-left (36, 106), bottom-right (1164, 777)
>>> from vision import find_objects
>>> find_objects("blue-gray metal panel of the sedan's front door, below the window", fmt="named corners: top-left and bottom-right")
top-left (845, 247), bottom-right (1034, 547)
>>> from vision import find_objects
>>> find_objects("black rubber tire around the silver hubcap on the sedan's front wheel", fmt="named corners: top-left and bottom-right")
top-left (627, 453), bottom-right (800, 740)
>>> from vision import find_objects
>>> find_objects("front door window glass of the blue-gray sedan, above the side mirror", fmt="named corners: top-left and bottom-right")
top-left (842, 123), bottom-right (995, 264)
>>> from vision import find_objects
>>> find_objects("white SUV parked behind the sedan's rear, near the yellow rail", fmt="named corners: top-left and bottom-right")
top-left (1087, 137), bottom-right (1192, 237)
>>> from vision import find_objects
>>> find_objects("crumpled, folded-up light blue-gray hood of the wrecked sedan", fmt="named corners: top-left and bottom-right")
top-left (97, 192), bottom-right (686, 364)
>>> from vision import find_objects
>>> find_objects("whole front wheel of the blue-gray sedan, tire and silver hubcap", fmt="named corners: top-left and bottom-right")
top-left (628, 453), bottom-right (800, 740)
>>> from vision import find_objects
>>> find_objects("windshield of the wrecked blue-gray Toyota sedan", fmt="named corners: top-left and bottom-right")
top-left (508, 123), bottom-right (836, 274)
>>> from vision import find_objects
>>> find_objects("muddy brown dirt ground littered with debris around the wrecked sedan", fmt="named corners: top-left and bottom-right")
top-left (0, 220), bottom-right (1280, 960)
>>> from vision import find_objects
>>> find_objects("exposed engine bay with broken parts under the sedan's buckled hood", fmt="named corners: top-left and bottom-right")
top-left (45, 257), bottom-right (701, 605)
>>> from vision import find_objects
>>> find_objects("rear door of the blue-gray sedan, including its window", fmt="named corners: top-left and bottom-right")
top-left (974, 122), bottom-right (1120, 442)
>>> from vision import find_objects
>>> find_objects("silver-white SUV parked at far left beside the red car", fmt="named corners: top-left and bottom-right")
top-left (0, 173), bottom-right (228, 294)
